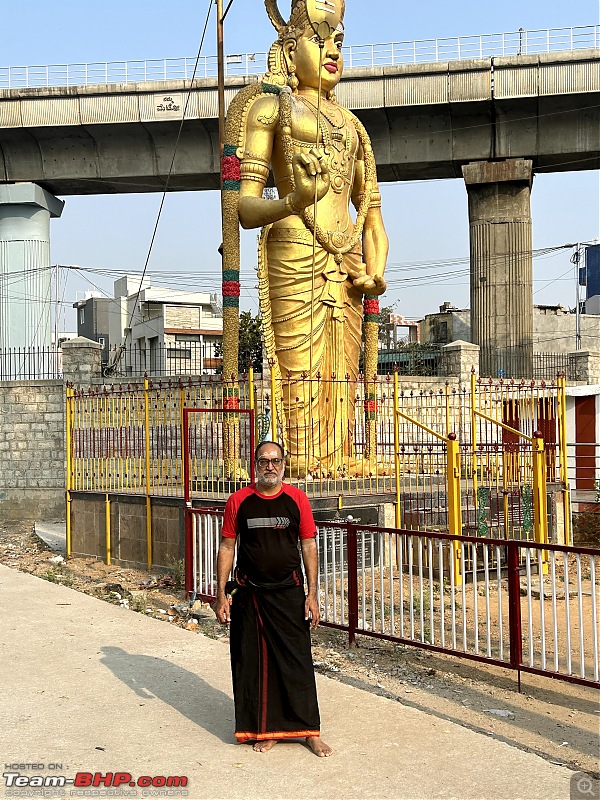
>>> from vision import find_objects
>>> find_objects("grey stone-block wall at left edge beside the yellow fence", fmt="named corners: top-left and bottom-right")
top-left (0, 381), bottom-right (65, 521)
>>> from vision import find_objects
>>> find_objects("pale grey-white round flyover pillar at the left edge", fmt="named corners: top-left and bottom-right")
top-left (0, 183), bottom-right (64, 349)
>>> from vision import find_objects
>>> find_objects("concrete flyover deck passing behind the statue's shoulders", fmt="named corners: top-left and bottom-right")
top-left (0, 48), bottom-right (600, 196)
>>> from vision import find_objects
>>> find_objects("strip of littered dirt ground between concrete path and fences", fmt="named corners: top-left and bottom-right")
top-left (0, 523), bottom-right (600, 777)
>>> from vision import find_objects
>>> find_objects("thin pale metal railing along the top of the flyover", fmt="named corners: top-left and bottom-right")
top-left (0, 25), bottom-right (600, 89)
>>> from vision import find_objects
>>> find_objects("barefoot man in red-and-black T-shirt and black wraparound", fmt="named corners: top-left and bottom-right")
top-left (215, 442), bottom-right (331, 756)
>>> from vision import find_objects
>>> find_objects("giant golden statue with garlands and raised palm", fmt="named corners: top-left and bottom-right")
top-left (222, 0), bottom-right (388, 476)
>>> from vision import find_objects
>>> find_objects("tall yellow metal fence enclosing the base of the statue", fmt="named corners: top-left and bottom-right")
top-left (66, 373), bottom-right (570, 543)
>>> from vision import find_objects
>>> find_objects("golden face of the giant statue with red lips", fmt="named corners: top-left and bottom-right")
top-left (290, 27), bottom-right (344, 92)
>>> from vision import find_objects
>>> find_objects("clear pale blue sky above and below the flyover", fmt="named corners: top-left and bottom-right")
top-left (0, 0), bottom-right (600, 327)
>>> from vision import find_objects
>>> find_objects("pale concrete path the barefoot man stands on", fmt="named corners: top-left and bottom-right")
top-left (0, 566), bottom-right (573, 800)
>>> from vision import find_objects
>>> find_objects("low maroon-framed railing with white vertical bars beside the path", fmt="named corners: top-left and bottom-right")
top-left (187, 509), bottom-right (600, 687)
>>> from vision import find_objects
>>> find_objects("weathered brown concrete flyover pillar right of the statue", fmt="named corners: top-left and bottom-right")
top-left (462, 159), bottom-right (533, 378)
